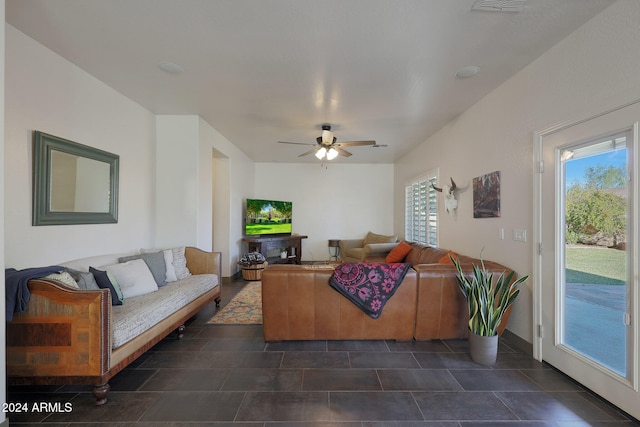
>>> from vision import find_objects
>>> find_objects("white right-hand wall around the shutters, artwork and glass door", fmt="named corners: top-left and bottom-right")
top-left (395, 0), bottom-right (640, 342)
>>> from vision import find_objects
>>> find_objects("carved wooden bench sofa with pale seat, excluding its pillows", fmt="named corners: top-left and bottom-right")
top-left (6, 247), bottom-right (221, 405)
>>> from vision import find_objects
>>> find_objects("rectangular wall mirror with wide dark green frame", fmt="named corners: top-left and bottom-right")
top-left (32, 131), bottom-right (120, 225)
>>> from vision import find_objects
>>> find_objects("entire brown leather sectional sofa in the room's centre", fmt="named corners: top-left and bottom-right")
top-left (262, 243), bottom-right (511, 341)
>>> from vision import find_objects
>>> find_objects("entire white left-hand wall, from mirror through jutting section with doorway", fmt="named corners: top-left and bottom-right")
top-left (4, 25), bottom-right (254, 276)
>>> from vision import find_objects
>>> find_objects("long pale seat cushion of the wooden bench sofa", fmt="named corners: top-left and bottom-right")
top-left (112, 274), bottom-right (219, 349)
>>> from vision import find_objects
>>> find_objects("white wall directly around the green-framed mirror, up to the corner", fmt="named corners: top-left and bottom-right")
top-left (3, 21), bottom-right (155, 268)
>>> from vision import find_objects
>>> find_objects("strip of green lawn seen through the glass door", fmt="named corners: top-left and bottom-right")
top-left (566, 246), bottom-right (627, 285)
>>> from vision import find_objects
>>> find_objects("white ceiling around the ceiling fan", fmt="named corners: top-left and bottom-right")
top-left (6, 0), bottom-right (613, 163)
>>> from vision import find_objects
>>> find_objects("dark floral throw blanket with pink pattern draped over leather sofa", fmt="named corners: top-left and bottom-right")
top-left (329, 262), bottom-right (411, 319)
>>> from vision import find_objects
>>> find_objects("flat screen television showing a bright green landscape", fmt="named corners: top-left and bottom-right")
top-left (244, 199), bottom-right (292, 236)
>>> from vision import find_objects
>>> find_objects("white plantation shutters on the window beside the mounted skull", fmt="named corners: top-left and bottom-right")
top-left (404, 171), bottom-right (438, 246)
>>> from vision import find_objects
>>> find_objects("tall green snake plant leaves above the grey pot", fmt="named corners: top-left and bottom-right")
top-left (449, 255), bottom-right (529, 337)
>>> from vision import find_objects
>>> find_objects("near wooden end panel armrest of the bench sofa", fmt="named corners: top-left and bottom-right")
top-left (6, 279), bottom-right (112, 379)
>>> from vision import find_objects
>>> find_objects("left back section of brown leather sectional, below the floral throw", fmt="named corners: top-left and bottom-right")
top-left (262, 264), bottom-right (417, 341)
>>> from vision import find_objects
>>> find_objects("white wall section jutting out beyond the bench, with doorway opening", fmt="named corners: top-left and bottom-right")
top-left (154, 115), bottom-right (253, 277)
